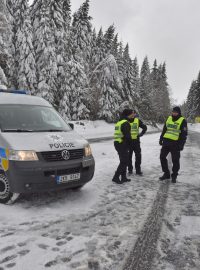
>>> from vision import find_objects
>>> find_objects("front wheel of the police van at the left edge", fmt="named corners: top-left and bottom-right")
top-left (0, 173), bottom-right (20, 204)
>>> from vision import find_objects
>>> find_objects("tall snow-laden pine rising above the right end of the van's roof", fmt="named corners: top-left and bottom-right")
top-left (31, 0), bottom-right (57, 104)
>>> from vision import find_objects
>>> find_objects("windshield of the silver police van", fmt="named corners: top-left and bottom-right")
top-left (0, 104), bottom-right (71, 132)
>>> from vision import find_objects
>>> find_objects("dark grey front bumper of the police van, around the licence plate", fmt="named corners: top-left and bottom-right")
top-left (6, 156), bottom-right (95, 193)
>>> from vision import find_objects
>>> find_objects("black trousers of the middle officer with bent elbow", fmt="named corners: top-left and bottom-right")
top-left (128, 140), bottom-right (142, 172)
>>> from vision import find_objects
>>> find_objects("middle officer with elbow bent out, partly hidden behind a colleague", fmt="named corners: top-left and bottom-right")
top-left (128, 111), bottom-right (147, 176)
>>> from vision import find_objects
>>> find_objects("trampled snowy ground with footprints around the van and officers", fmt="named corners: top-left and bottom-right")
top-left (0, 124), bottom-right (200, 270)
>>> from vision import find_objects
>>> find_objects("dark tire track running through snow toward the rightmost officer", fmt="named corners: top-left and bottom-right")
top-left (123, 181), bottom-right (169, 270)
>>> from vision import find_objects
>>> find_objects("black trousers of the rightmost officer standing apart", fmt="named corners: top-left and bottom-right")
top-left (160, 144), bottom-right (180, 176)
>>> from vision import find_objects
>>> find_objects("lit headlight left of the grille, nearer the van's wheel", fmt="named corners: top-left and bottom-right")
top-left (9, 150), bottom-right (38, 161)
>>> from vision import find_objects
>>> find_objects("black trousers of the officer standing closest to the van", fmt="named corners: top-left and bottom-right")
top-left (114, 142), bottom-right (129, 175)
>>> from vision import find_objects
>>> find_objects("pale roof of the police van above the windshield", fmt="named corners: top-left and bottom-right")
top-left (0, 93), bottom-right (52, 107)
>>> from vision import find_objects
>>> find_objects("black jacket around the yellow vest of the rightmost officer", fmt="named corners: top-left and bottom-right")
top-left (160, 115), bottom-right (188, 150)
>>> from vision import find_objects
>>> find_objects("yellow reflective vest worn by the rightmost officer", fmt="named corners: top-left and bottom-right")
top-left (163, 116), bottom-right (184, 141)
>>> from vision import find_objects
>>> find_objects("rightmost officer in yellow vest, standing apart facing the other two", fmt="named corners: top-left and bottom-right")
top-left (159, 107), bottom-right (187, 183)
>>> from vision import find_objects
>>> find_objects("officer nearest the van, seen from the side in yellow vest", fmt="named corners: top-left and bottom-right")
top-left (112, 109), bottom-right (133, 184)
